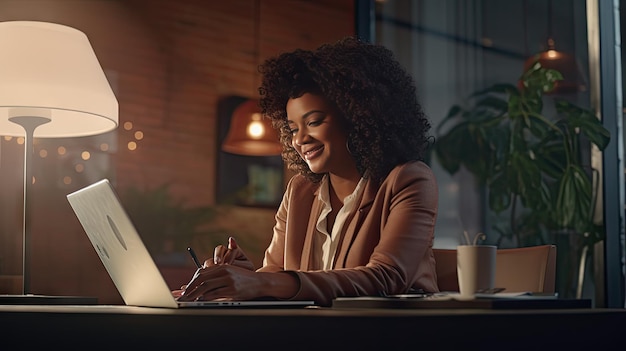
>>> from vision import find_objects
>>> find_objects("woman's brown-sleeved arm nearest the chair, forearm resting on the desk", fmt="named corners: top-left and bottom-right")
top-left (284, 162), bottom-right (438, 305)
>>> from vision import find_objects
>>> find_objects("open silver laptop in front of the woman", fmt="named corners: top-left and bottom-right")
top-left (67, 179), bottom-right (314, 308)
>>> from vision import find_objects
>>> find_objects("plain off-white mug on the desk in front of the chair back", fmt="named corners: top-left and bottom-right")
top-left (456, 245), bottom-right (497, 297)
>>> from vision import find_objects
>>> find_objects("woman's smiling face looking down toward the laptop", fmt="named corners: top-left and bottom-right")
top-left (287, 93), bottom-right (356, 175)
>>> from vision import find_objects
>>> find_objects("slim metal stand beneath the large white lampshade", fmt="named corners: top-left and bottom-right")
top-left (9, 116), bottom-right (50, 295)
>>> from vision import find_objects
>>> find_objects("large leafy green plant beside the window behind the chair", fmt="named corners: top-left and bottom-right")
top-left (433, 62), bottom-right (610, 296)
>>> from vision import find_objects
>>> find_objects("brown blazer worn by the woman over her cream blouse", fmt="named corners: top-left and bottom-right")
top-left (258, 161), bottom-right (438, 306)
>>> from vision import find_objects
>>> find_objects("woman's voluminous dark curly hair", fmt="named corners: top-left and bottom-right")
top-left (259, 37), bottom-right (431, 182)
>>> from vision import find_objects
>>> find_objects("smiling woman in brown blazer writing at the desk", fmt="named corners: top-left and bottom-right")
top-left (175, 37), bottom-right (438, 306)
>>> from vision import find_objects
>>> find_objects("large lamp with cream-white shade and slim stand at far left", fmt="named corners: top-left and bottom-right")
top-left (0, 21), bottom-right (118, 295)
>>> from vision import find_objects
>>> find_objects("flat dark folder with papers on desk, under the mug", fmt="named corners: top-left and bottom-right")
top-left (332, 293), bottom-right (592, 309)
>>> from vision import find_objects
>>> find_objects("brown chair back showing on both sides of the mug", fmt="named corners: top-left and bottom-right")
top-left (433, 245), bottom-right (556, 294)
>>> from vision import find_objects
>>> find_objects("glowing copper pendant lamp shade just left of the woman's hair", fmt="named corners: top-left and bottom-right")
top-left (222, 100), bottom-right (282, 156)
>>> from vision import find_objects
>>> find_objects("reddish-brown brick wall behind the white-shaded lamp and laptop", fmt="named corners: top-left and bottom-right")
top-left (0, 0), bottom-right (354, 303)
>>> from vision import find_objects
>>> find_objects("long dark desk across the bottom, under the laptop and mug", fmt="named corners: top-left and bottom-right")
top-left (0, 305), bottom-right (626, 351)
